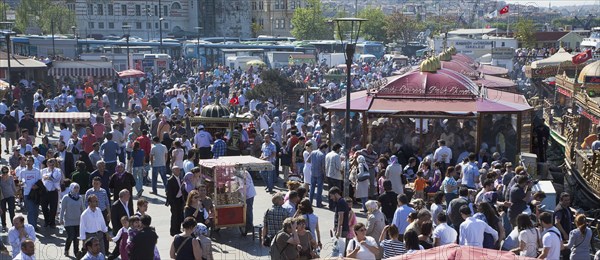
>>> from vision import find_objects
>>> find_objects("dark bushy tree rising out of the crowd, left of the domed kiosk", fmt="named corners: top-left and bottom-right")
top-left (246, 69), bottom-right (294, 101)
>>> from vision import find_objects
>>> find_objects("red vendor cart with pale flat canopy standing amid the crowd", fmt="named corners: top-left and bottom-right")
top-left (199, 156), bottom-right (273, 233)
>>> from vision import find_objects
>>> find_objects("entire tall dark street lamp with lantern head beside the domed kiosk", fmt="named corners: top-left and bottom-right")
top-left (333, 17), bottom-right (367, 198)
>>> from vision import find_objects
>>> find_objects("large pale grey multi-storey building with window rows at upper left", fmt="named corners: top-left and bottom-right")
top-left (72, 0), bottom-right (251, 40)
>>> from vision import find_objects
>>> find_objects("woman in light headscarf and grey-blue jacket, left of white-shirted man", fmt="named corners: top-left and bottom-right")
top-left (59, 182), bottom-right (85, 256)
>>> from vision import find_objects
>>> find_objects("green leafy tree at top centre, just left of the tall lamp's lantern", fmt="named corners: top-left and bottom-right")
top-left (291, 0), bottom-right (333, 40)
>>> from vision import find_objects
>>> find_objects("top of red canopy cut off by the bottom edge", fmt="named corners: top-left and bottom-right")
top-left (390, 244), bottom-right (535, 260)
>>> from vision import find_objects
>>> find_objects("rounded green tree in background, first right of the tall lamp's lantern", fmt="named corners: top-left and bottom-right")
top-left (385, 11), bottom-right (425, 44)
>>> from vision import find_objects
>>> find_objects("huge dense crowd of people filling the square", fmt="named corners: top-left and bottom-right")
top-left (0, 52), bottom-right (592, 259)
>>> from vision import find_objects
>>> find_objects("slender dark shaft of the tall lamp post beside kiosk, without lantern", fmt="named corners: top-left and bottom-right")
top-left (344, 43), bottom-right (356, 197)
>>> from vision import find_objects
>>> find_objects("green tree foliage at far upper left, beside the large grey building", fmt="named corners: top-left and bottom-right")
top-left (15, 0), bottom-right (76, 34)
